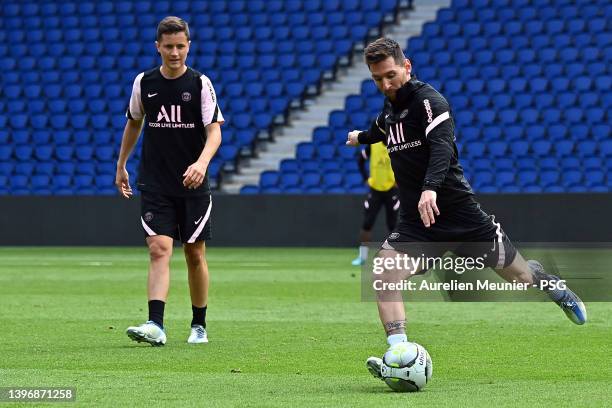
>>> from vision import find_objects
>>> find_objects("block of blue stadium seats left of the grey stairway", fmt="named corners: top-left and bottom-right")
top-left (0, 0), bottom-right (397, 195)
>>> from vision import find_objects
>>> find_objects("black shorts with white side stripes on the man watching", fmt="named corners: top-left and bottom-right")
top-left (140, 191), bottom-right (212, 244)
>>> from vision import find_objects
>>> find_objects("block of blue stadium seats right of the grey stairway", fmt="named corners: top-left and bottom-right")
top-left (241, 0), bottom-right (612, 194)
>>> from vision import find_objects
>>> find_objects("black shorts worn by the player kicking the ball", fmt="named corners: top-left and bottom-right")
top-left (381, 200), bottom-right (516, 272)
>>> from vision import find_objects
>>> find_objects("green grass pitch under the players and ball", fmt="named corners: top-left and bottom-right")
top-left (0, 247), bottom-right (612, 408)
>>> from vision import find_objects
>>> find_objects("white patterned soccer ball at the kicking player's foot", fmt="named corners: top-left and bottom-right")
top-left (380, 342), bottom-right (433, 392)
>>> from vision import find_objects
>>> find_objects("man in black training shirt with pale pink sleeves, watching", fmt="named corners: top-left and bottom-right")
top-left (115, 16), bottom-right (224, 346)
